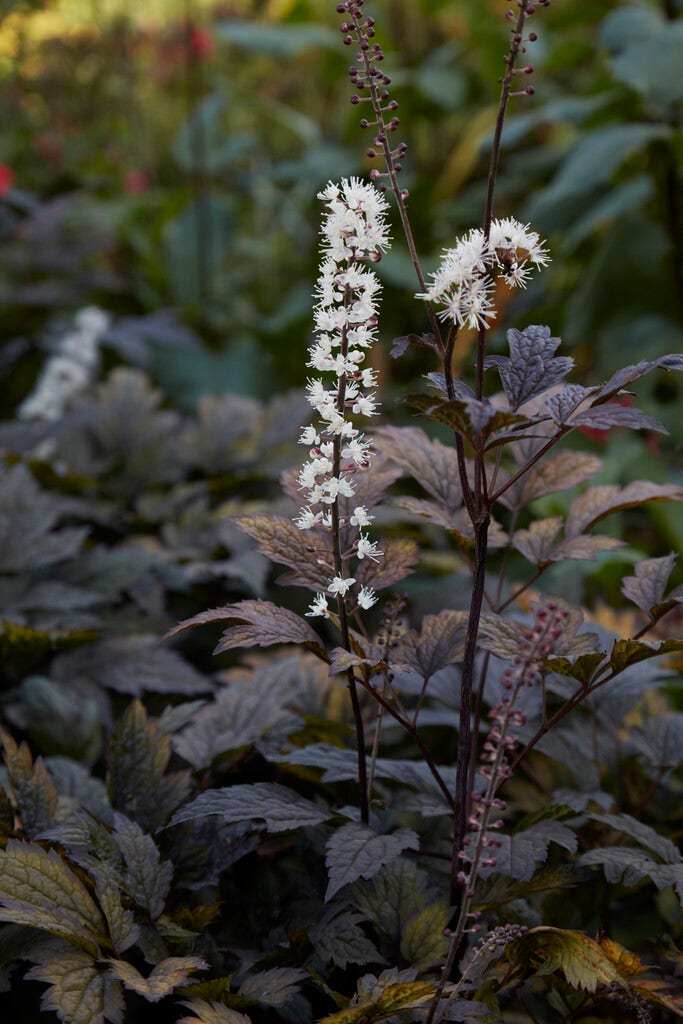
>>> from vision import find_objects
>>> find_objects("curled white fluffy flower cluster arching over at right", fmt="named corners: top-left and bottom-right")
top-left (417, 217), bottom-right (550, 329)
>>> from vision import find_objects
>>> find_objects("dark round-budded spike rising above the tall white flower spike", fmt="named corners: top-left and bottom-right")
top-left (337, 0), bottom-right (408, 199)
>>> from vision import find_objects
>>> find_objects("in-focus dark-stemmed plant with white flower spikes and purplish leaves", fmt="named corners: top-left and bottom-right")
top-left (167, 0), bottom-right (683, 1024)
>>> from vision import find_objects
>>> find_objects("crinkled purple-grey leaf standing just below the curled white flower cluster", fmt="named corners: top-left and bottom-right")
top-left (485, 326), bottom-right (573, 412)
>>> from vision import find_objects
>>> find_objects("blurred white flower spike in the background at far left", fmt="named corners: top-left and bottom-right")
top-left (17, 306), bottom-right (110, 422)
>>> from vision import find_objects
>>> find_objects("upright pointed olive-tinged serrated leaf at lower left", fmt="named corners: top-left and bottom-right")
top-left (106, 700), bottom-right (189, 833)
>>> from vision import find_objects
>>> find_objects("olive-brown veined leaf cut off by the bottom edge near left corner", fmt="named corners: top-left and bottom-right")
top-left (25, 948), bottom-right (124, 1024)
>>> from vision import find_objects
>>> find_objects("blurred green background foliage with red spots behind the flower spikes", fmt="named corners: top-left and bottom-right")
top-left (0, 0), bottom-right (683, 549)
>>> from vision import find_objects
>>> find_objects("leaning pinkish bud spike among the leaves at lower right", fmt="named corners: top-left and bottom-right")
top-left (458, 601), bottom-right (568, 897)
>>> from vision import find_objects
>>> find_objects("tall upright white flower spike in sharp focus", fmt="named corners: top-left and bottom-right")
top-left (295, 178), bottom-right (389, 616)
